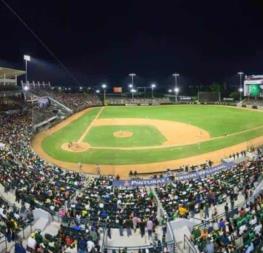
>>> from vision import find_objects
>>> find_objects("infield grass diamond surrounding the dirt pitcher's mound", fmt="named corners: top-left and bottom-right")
top-left (84, 126), bottom-right (166, 147)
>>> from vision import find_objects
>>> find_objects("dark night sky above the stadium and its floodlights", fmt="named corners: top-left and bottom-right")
top-left (0, 0), bottom-right (263, 85)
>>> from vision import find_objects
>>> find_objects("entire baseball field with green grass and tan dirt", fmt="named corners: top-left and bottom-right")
top-left (32, 105), bottom-right (263, 175)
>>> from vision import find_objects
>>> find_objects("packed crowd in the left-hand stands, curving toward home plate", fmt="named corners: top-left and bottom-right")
top-left (0, 111), bottom-right (84, 211)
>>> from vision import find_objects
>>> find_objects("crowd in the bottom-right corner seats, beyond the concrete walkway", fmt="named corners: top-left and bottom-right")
top-left (192, 195), bottom-right (263, 253)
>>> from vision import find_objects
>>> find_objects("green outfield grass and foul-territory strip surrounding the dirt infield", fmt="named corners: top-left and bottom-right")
top-left (42, 105), bottom-right (263, 165)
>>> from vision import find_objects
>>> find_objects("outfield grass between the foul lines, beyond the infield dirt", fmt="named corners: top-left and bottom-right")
top-left (100, 105), bottom-right (263, 137)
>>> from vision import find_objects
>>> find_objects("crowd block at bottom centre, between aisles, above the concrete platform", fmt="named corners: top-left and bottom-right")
top-left (61, 177), bottom-right (159, 237)
